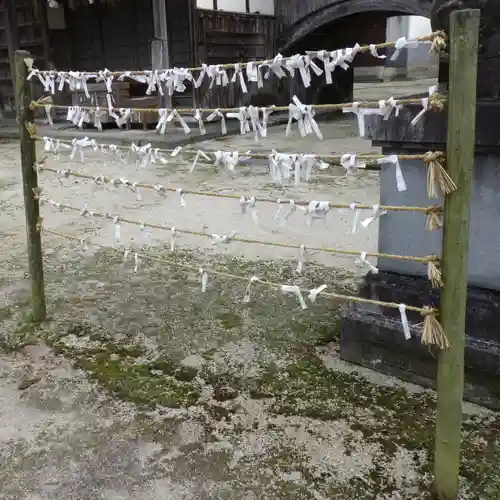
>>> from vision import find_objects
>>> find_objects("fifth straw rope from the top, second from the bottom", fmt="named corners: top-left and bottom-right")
top-left (38, 198), bottom-right (439, 265)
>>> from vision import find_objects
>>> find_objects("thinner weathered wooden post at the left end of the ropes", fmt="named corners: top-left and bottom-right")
top-left (14, 50), bottom-right (46, 323)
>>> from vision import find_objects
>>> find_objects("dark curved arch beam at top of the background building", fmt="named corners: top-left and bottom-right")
top-left (276, 0), bottom-right (432, 50)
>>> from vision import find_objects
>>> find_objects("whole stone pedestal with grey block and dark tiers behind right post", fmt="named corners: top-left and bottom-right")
top-left (340, 43), bottom-right (500, 410)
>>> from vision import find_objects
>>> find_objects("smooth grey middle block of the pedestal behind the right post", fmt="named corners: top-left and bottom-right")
top-left (378, 155), bottom-right (500, 290)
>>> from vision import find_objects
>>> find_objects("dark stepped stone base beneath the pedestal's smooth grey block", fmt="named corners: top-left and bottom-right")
top-left (340, 273), bottom-right (500, 411)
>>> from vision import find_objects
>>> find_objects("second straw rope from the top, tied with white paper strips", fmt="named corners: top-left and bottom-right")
top-left (30, 93), bottom-right (447, 113)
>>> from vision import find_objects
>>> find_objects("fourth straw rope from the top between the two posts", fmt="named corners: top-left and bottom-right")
top-left (34, 158), bottom-right (443, 215)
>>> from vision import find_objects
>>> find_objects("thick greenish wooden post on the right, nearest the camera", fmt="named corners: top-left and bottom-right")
top-left (434, 9), bottom-right (480, 500)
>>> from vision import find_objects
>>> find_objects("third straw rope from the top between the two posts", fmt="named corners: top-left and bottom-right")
top-left (31, 135), bottom-right (445, 167)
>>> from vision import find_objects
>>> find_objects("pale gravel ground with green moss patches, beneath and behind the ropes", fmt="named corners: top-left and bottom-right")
top-left (0, 114), bottom-right (500, 500)
